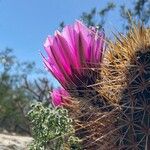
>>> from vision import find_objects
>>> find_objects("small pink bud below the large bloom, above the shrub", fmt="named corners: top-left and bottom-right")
top-left (51, 88), bottom-right (69, 107)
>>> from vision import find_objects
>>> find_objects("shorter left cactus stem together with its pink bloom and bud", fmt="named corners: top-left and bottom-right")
top-left (43, 21), bottom-right (117, 149)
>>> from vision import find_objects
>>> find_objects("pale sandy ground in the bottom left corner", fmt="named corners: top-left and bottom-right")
top-left (0, 134), bottom-right (32, 150)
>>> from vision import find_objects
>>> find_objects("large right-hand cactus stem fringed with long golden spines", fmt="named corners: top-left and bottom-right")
top-left (100, 25), bottom-right (150, 150)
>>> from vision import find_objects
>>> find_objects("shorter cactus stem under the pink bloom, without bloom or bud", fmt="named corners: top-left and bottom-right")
top-left (68, 70), bottom-right (117, 150)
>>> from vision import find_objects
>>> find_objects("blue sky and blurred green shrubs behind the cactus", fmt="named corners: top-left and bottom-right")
top-left (0, 0), bottom-right (150, 135)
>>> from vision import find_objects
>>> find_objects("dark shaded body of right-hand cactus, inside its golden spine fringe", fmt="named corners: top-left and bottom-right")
top-left (119, 48), bottom-right (150, 150)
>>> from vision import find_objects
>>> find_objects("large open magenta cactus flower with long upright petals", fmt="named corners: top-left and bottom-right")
top-left (43, 21), bottom-right (105, 89)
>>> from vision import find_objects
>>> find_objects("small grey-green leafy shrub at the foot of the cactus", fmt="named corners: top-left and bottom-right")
top-left (28, 103), bottom-right (80, 150)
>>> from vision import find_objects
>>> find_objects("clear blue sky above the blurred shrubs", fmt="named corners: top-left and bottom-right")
top-left (0, 0), bottom-right (131, 84)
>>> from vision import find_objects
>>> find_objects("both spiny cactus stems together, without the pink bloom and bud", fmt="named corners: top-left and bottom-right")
top-left (68, 26), bottom-right (150, 150)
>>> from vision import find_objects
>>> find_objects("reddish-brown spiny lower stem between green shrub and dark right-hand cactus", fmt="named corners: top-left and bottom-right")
top-left (75, 100), bottom-right (118, 150)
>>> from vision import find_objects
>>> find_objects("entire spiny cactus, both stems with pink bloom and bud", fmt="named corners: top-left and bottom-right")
top-left (43, 21), bottom-right (150, 150)
